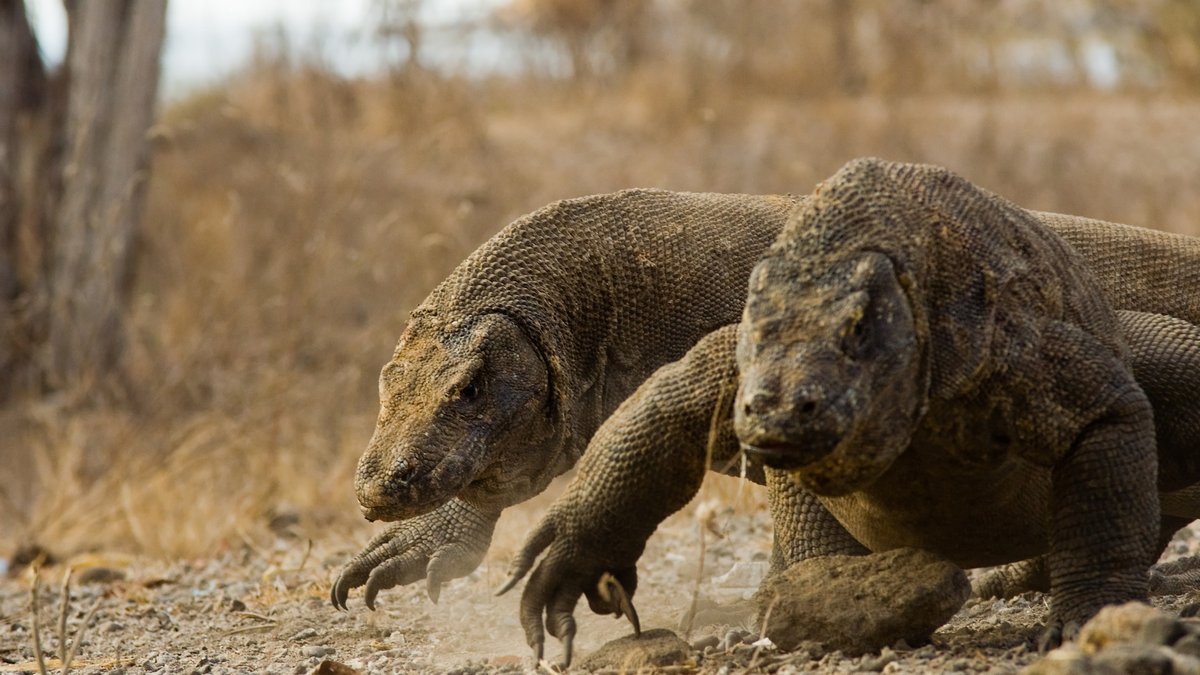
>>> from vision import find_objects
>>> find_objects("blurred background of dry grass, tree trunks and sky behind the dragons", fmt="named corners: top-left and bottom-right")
top-left (0, 0), bottom-right (1200, 556)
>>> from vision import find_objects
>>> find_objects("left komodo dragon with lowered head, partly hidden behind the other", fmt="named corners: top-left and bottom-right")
top-left (330, 190), bottom-right (796, 609)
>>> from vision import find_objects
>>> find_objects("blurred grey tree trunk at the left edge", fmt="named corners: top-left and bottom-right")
top-left (0, 0), bottom-right (166, 400)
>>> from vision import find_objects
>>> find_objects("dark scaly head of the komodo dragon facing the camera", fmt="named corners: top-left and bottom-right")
top-left (734, 251), bottom-right (924, 495)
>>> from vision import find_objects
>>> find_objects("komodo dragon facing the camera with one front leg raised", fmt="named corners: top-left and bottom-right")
top-left (502, 161), bottom-right (1200, 661)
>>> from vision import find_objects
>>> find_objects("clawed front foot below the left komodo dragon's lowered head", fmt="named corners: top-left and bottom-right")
top-left (329, 500), bottom-right (499, 610)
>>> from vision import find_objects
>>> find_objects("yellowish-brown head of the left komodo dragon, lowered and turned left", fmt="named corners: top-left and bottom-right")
top-left (354, 313), bottom-right (554, 520)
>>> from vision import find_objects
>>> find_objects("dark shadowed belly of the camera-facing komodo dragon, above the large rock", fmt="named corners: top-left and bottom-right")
top-left (821, 449), bottom-right (1050, 567)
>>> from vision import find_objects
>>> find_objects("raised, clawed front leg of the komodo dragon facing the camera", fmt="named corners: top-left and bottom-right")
top-left (500, 325), bottom-right (737, 663)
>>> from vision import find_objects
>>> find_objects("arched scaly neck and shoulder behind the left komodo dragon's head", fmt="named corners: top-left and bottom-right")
top-left (427, 190), bottom-right (797, 464)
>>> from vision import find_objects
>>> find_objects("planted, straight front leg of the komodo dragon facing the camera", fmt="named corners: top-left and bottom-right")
top-left (1030, 323), bottom-right (1159, 647)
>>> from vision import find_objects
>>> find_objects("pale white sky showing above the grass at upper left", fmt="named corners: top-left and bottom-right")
top-left (26, 0), bottom-right (500, 97)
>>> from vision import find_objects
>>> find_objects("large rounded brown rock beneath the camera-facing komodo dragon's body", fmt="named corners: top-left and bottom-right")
top-left (755, 549), bottom-right (971, 655)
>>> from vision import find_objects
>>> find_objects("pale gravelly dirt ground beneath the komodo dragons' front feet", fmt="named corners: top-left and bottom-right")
top-left (7, 487), bottom-right (1196, 675)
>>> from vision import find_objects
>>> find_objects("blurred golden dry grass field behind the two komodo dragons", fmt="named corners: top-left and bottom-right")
top-left (0, 30), bottom-right (1200, 556)
